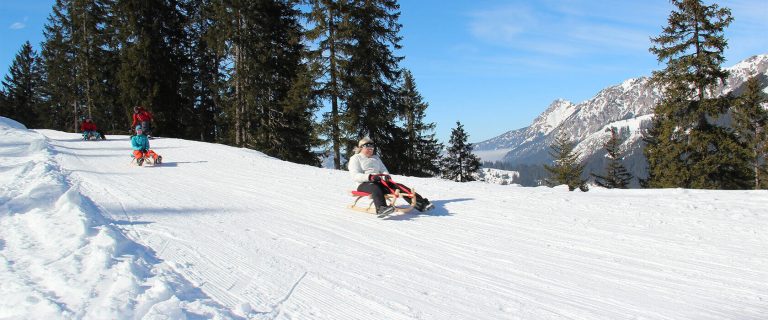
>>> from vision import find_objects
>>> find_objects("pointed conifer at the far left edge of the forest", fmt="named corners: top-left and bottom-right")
top-left (2, 41), bottom-right (43, 128)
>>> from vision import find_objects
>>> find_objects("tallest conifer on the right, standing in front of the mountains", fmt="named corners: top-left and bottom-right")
top-left (644, 0), bottom-right (748, 189)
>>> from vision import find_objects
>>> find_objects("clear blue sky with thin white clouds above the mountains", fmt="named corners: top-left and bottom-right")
top-left (0, 0), bottom-right (768, 142)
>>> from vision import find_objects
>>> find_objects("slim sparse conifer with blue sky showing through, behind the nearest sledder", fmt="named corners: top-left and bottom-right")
top-left (306, 0), bottom-right (351, 170)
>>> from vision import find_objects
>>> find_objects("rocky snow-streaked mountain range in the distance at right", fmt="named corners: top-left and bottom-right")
top-left (474, 54), bottom-right (768, 183)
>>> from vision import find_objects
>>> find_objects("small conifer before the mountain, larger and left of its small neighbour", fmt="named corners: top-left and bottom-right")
top-left (544, 131), bottom-right (588, 191)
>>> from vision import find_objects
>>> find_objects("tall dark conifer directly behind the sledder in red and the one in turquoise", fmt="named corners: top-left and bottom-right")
top-left (114, 0), bottom-right (191, 136)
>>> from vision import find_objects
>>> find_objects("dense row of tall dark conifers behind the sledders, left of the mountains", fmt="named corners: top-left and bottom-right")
top-left (0, 0), bottom-right (460, 176)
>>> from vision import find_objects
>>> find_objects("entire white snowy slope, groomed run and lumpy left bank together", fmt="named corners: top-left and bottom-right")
top-left (0, 118), bottom-right (768, 319)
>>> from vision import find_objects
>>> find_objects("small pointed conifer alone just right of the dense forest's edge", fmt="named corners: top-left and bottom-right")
top-left (440, 121), bottom-right (480, 182)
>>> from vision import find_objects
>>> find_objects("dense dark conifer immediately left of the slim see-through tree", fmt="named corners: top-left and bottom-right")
top-left (249, 0), bottom-right (316, 163)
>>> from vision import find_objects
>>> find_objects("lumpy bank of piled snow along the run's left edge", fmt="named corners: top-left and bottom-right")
top-left (0, 117), bottom-right (230, 319)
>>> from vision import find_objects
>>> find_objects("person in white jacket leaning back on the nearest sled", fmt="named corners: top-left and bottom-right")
top-left (347, 137), bottom-right (435, 217)
